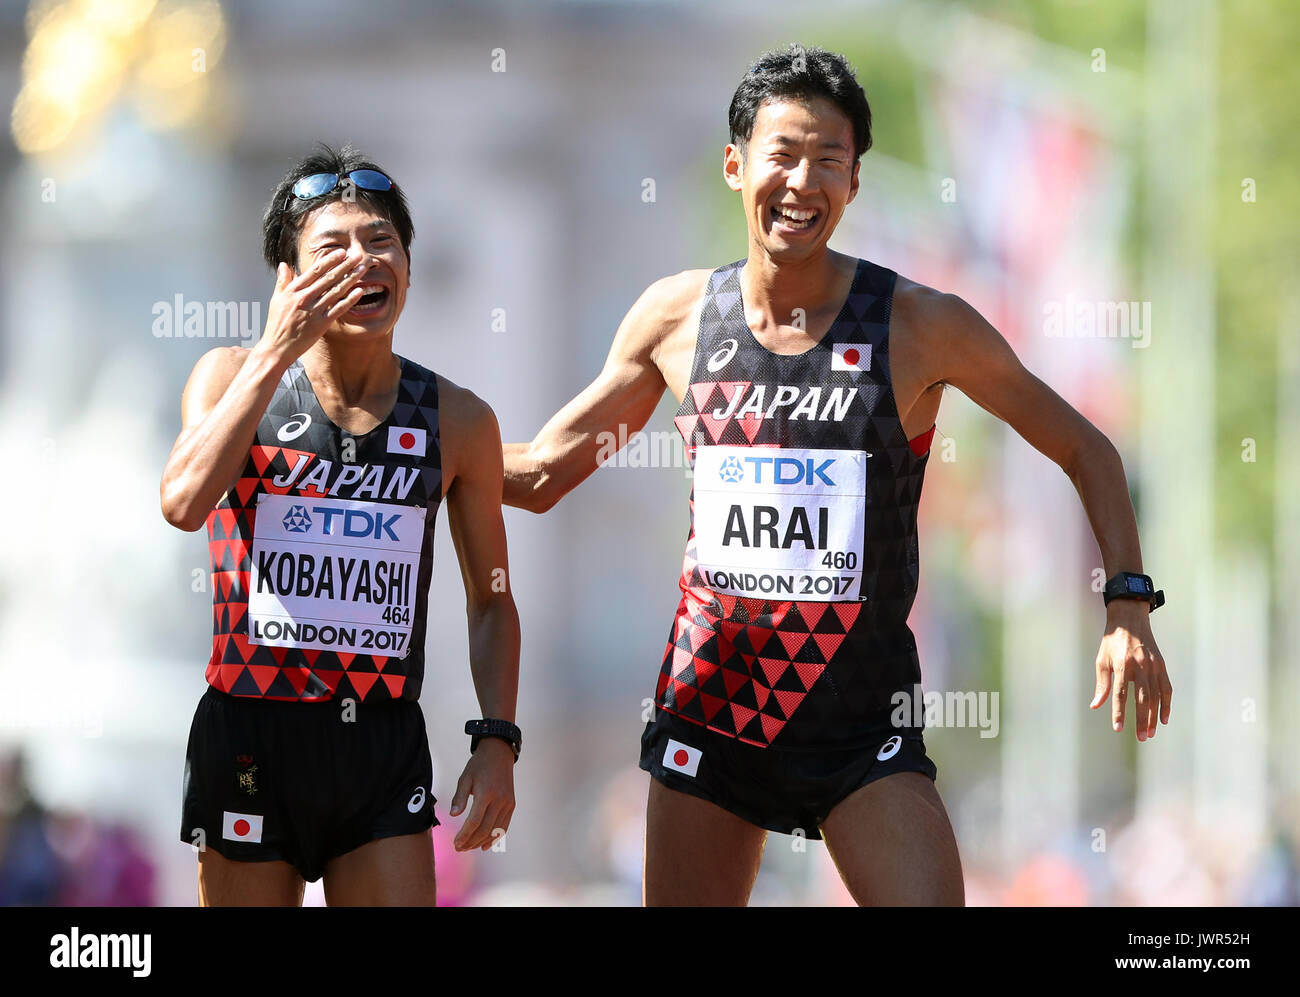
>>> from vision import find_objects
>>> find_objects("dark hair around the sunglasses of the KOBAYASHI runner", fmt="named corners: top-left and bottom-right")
top-left (261, 143), bottom-right (415, 269)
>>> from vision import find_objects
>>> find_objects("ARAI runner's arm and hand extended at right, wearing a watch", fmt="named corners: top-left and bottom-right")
top-left (919, 289), bottom-right (1174, 741)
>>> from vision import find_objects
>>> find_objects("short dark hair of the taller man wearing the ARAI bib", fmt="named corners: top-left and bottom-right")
top-left (727, 43), bottom-right (871, 160)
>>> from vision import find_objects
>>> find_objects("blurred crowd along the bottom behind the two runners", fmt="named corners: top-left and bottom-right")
top-left (0, 751), bottom-right (1300, 906)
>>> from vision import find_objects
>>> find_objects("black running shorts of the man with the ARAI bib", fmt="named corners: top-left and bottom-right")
top-left (641, 708), bottom-right (939, 840)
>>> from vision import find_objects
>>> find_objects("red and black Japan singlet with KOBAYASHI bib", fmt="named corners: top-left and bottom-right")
top-left (207, 357), bottom-right (442, 702)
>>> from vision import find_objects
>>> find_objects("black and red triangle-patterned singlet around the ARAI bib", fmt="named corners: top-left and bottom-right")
top-left (655, 260), bottom-right (933, 747)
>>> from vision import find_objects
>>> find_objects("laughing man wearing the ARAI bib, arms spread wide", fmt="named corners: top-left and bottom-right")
top-left (504, 47), bottom-right (1171, 905)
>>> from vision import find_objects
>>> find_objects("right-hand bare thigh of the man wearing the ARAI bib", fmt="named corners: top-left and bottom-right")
top-left (822, 772), bottom-right (966, 906)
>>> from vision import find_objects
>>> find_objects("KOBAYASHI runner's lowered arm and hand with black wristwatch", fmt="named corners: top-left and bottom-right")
top-left (439, 381), bottom-right (519, 851)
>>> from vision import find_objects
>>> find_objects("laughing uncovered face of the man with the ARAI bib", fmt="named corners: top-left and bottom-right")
top-left (723, 97), bottom-right (858, 261)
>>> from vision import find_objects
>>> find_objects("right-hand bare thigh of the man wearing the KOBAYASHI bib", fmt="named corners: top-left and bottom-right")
top-left (325, 831), bottom-right (437, 907)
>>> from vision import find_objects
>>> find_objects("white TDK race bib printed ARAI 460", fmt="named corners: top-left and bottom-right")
top-left (694, 446), bottom-right (871, 602)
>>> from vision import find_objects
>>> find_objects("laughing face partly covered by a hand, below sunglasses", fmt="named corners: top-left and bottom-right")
top-left (298, 198), bottom-right (411, 335)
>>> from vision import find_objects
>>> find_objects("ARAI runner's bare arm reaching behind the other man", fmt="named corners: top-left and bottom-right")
top-left (504, 270), bottom-right (707, 512)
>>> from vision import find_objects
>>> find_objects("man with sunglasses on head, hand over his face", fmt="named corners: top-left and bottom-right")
top-left (154, 147), bottom-right (520, 906)
